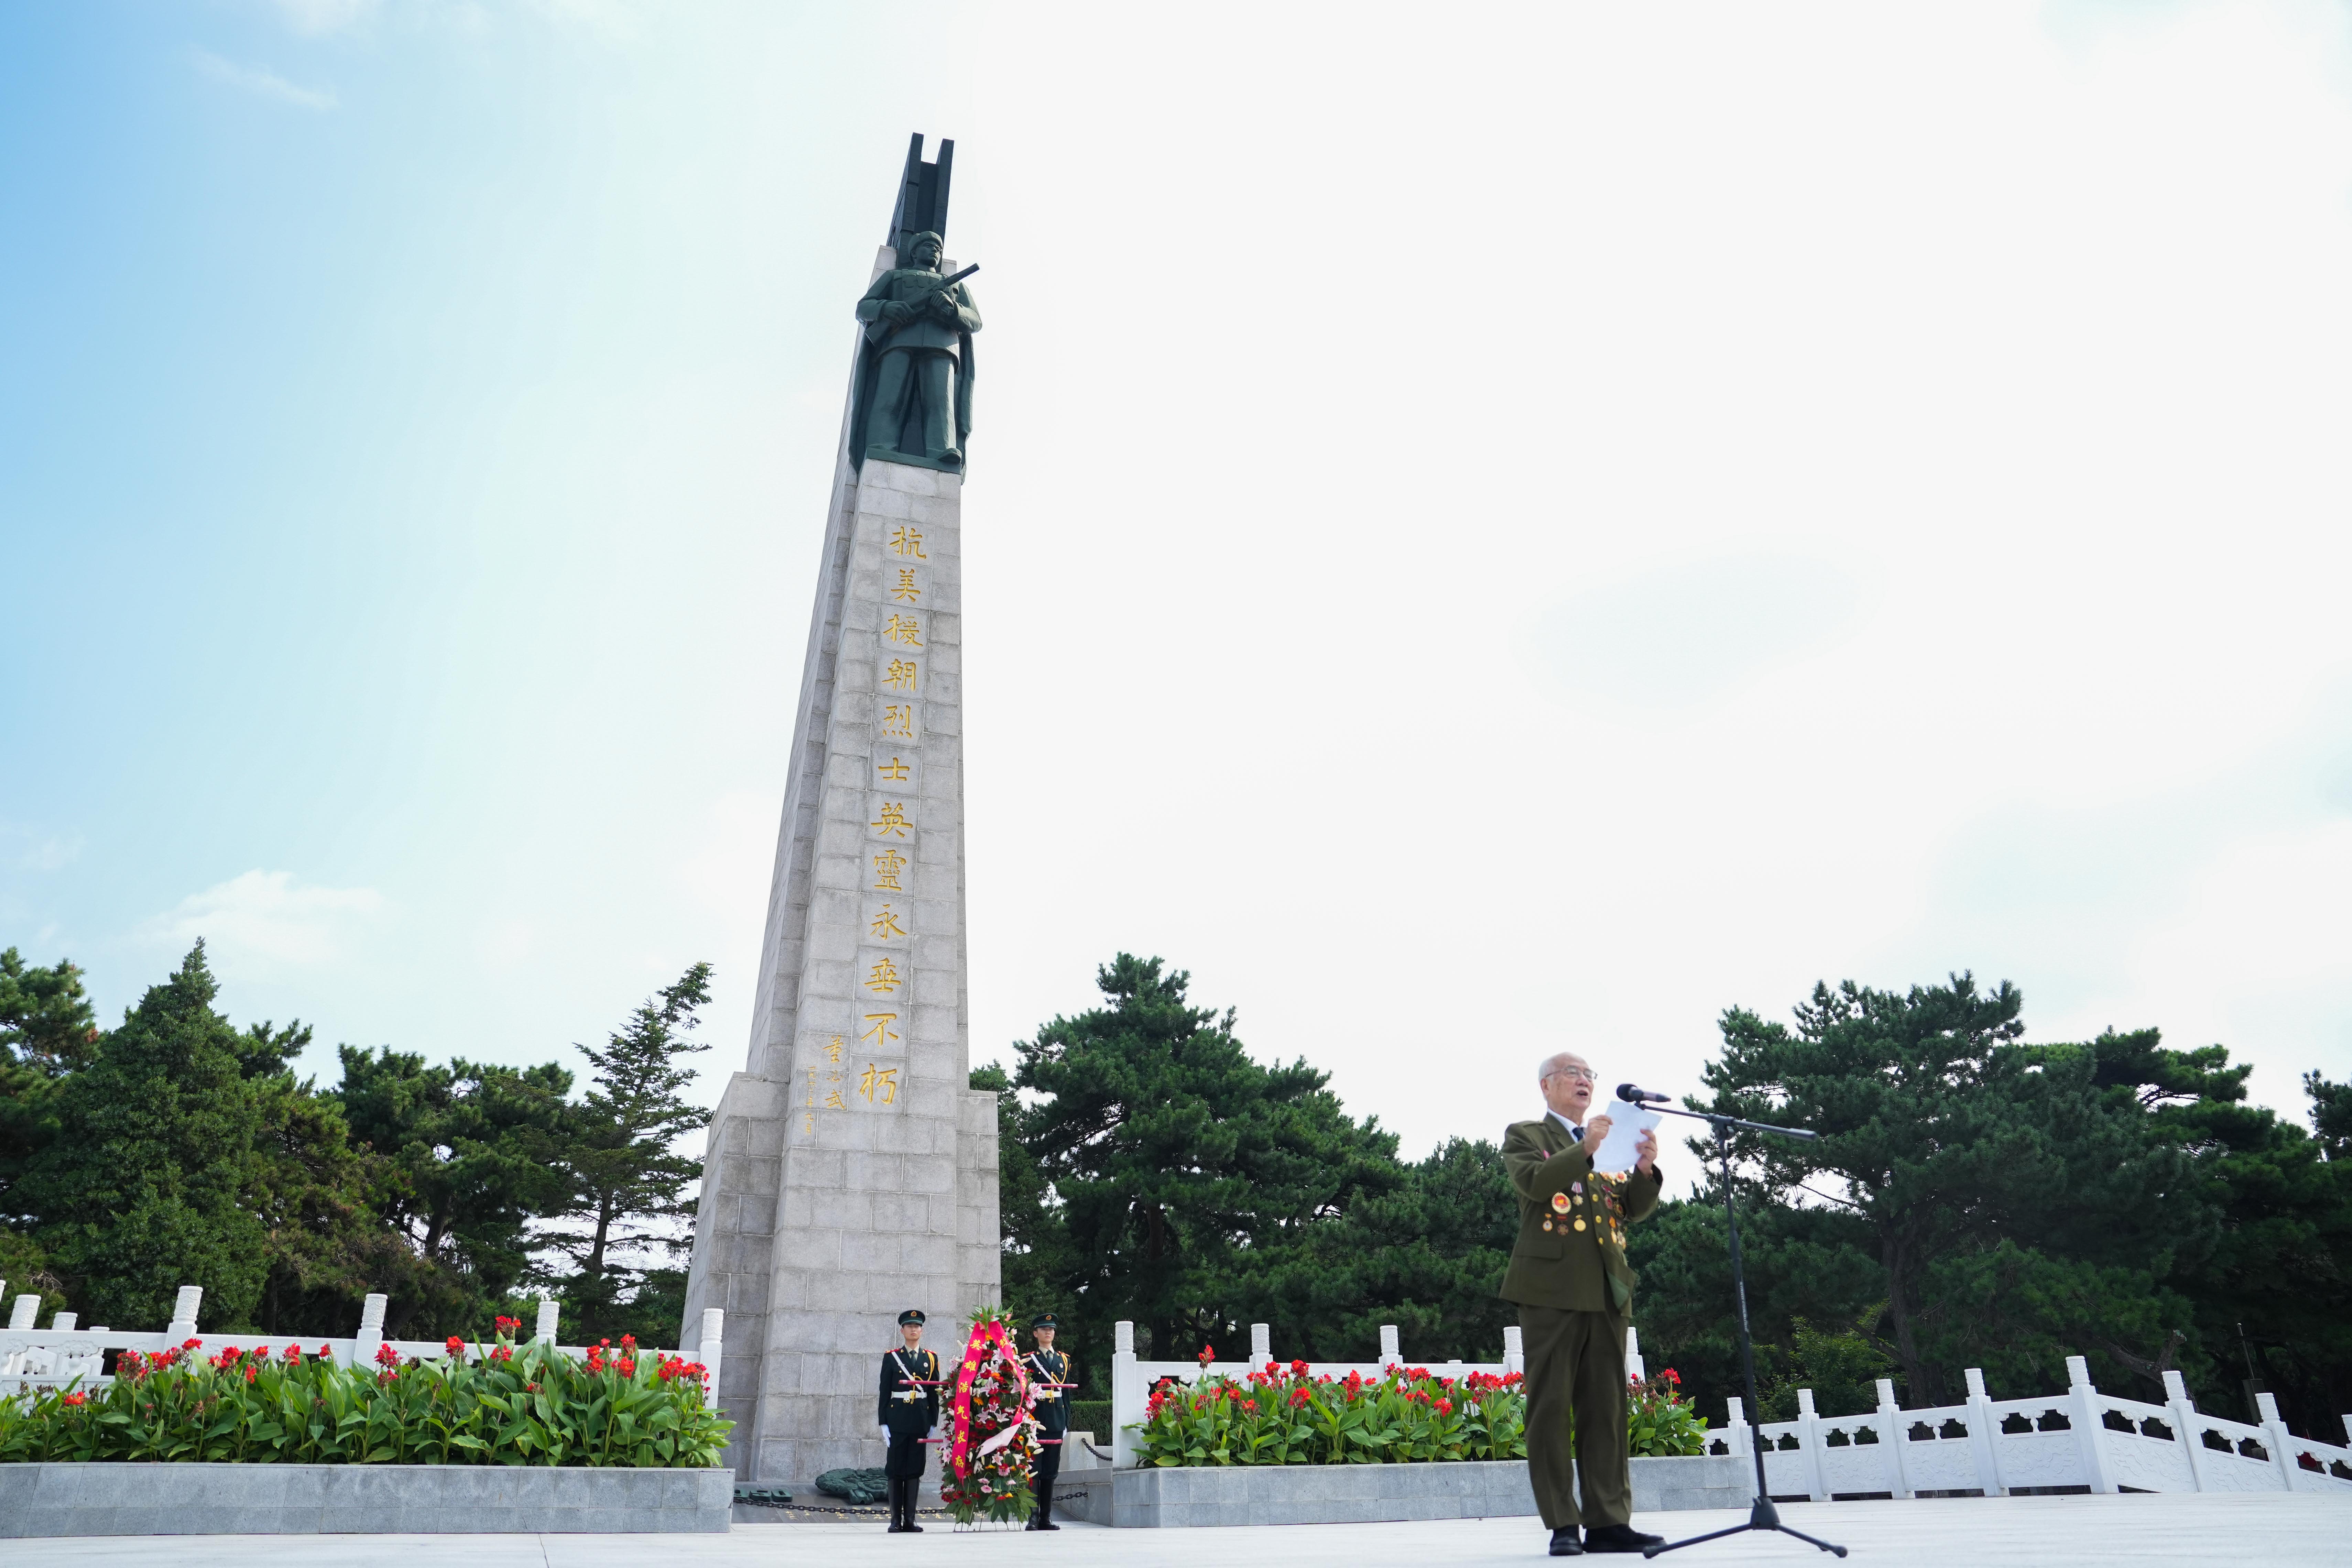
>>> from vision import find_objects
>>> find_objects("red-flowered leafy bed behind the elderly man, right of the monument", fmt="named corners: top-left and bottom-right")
top-left (1134, 1352), bottom-right (1705, 1467)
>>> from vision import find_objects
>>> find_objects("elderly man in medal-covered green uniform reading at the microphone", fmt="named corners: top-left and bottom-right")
top-left (1503, 1051), bottom-right (1660, 1556)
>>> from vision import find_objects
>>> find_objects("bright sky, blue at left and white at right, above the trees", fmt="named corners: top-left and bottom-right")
top-left (0, 0), bottom-right (2352, 1175)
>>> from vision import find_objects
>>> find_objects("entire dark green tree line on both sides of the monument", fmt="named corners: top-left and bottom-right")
top-left (0, 945), bottom-right (2352, 1436)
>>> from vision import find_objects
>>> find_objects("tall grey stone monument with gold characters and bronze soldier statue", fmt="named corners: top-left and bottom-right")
top-left (687, 137), bottom-right (1000, 1483)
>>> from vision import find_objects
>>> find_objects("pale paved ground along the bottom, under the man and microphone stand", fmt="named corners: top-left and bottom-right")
top-left (5, 1493), bottom-right (2352, 1568)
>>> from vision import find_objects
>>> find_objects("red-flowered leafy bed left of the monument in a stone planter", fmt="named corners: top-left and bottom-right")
top-left (0, 1319), bottom-right (734, 1469)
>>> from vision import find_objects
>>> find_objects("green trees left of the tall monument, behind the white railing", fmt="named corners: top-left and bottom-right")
top-left (0, 943), bottom-right (710, 1345)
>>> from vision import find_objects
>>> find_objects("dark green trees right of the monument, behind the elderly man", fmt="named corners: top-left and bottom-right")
top-left (974, 955), bottom-right (2352, 1436)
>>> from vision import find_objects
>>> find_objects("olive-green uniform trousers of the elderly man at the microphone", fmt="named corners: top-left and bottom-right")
top-left (1520, 1302), bottom-right (1632, 1531)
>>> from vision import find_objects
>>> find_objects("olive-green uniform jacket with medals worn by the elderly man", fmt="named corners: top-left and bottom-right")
top-left (1503, 1117), bottom-right (1660, 1316)
